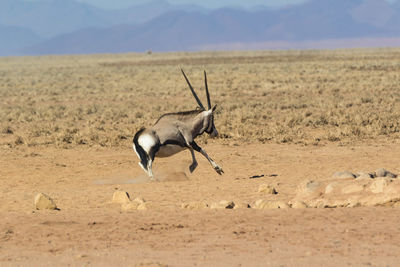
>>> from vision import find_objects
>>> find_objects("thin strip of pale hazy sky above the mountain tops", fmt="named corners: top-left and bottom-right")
top-left (77, 0), bottom-right (307, 8)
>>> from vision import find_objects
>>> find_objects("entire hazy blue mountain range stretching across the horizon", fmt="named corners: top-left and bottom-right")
top-left (0, 0), bottom-right (400, 56)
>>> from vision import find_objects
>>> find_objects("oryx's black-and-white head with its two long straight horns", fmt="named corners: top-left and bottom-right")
top-left (181, 69), bottom-right (218, 137)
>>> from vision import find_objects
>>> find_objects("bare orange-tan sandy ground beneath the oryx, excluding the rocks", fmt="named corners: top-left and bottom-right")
top-left (0, 143), bottom-right (400, 266)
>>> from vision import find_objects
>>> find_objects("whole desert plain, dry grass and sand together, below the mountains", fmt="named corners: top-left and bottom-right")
top-left (0, 48), bottom-right (400, 266)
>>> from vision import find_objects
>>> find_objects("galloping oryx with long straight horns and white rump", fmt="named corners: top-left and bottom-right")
top-left (133, 69), bottom-right (224, 180)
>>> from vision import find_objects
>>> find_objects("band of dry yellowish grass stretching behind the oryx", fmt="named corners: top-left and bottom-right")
top-left (0, 49), bottom-right (400, 148)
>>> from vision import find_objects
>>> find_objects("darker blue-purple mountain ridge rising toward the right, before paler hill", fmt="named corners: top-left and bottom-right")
top-left (25, 0), bottom-right (400, 54)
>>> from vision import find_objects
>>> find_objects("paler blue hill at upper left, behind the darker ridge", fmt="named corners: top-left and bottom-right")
top-left (0, 0), bottom-right (207, 56)
